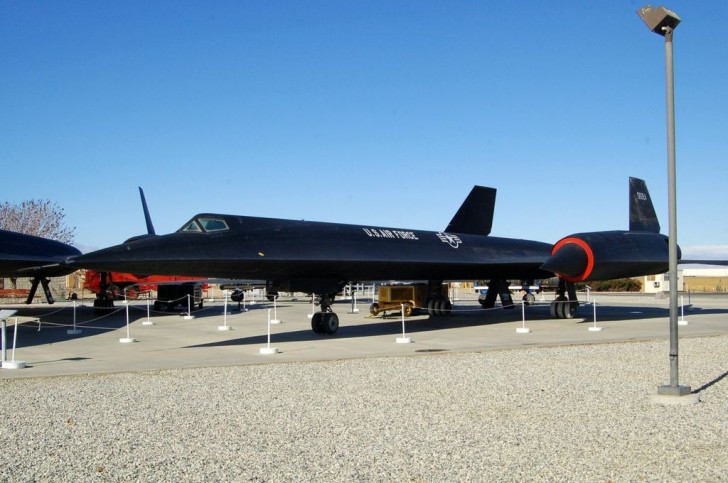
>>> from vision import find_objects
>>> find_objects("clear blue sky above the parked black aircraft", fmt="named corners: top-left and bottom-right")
top-left (0, 0), bottom-right (728, 256)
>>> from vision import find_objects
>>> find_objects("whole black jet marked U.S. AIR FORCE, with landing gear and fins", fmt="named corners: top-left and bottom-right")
top-left (69, 178), bottom-right (684, 334)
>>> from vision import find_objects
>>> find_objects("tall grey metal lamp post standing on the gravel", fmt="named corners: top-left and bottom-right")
top-left (637, 5), bottom-right (691, 396)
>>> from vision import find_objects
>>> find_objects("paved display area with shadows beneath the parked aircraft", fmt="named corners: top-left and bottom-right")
top-left (0, 294), bottom-right (728, 382)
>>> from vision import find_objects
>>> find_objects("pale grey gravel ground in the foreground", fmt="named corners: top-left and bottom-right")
top-left (0, 336), bottom-right (728, 482)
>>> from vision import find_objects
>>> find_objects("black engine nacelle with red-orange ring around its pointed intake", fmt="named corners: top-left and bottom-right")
top-left (541, 231), bottom-right (680, 282)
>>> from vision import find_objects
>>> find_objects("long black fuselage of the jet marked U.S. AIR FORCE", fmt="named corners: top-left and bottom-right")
top-left (75, 214), bottom-right (552, 290)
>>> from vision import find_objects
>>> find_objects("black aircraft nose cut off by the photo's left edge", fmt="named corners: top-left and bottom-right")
top-left (0, 230), bottom-right (81, 304)
